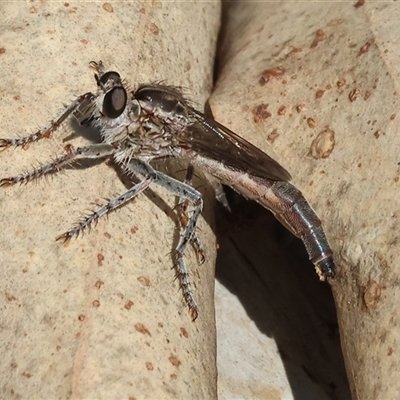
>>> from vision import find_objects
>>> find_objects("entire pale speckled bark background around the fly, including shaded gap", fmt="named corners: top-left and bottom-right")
top-left (0, 1), bottom-right (400, 400)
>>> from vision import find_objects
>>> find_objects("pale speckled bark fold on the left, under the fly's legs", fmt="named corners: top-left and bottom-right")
top-left (0, 1), bottom-right (220, 399)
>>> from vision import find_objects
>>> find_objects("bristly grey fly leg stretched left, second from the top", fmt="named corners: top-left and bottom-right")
top-left (0, 144), bottom-right (115, 187)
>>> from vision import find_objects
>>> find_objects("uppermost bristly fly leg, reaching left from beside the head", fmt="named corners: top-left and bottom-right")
top-left (0, 92), bottom-right (95, 150)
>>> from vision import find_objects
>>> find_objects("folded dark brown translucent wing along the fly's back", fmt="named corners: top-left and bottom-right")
top-left (179, 109), bottom-right (291, 181)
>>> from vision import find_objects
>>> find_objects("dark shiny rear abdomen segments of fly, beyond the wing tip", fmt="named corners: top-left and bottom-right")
top-left (271, 181), bottom-right (335, 280)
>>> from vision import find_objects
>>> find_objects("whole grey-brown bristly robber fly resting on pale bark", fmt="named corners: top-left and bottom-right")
top-left (0, 61), bottom-right (334, 320)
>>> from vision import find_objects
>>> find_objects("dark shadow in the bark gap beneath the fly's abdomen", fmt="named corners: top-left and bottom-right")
top-left (216, 188), bottom-right (351, 400)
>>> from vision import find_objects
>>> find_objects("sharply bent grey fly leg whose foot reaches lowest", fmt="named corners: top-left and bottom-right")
top-left (126, 160), bottom-right (203, 321)
